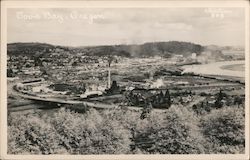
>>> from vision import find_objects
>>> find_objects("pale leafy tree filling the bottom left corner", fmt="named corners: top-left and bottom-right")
top-left (8, 114), bottom-right (62, 154)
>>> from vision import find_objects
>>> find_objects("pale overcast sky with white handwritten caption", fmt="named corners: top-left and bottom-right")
top-left (8, 8), bottom-right (245, 46)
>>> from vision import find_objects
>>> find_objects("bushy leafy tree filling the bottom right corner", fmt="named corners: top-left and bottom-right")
top-left (201, 107), bottom-right (245, 154)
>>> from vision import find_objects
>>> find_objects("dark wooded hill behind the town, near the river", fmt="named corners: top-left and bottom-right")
top-left (83, 41), bottom-right (204, 57)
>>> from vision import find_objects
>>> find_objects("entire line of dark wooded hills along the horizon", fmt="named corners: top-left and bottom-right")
top-left (7, 41), bottom-right (229, 57)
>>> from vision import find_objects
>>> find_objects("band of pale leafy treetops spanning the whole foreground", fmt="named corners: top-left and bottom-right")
top-left (8, 106), bottom-right (245, 154)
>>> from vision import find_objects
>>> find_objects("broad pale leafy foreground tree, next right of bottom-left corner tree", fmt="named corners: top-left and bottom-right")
top-left (50, 109), bottom-right (130, 154)
